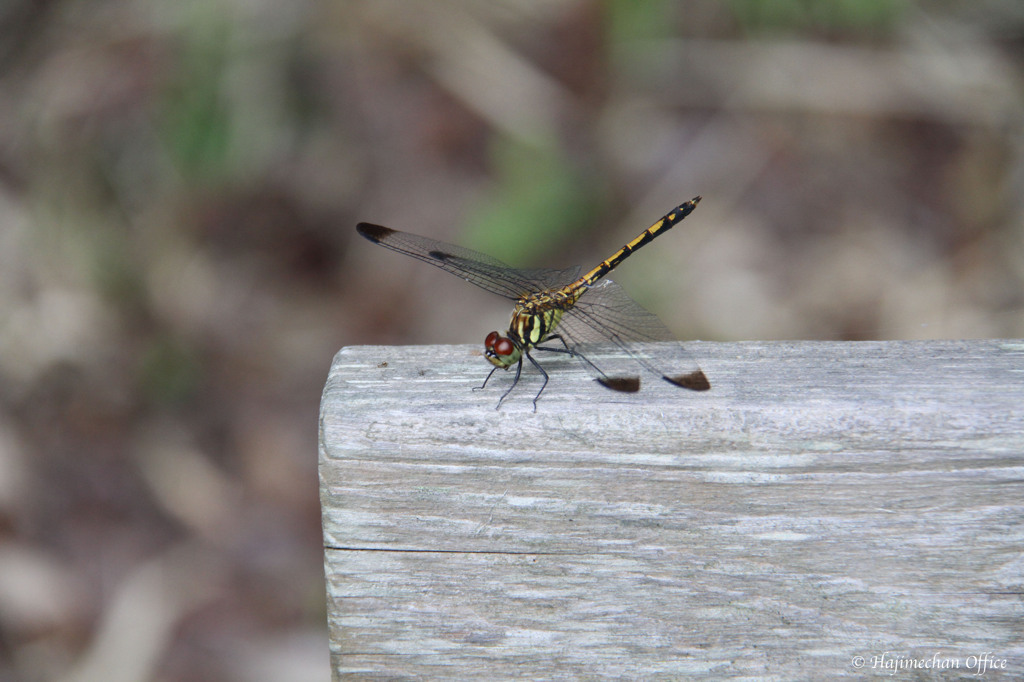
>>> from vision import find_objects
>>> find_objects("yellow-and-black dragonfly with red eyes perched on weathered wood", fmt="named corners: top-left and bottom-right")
top-left (355, 197), bottom-right (711, 412)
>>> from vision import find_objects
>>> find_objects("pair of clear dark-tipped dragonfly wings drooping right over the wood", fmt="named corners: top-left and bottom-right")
top-left (556, 280), bottom-right (711, 391)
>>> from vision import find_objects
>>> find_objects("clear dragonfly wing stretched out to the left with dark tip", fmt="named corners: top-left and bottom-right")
top-left (355, 222), bottom-right (580, 300)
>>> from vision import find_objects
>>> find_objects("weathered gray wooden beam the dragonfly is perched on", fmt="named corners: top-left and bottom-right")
top-left (319, 340), bottom-right (1024, 680)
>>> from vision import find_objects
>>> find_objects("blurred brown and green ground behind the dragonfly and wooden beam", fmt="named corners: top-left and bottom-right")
top-left (0, 0), bottom-right (1024, 682)
